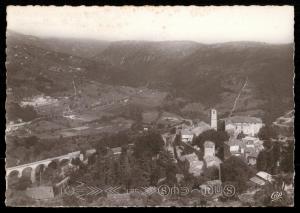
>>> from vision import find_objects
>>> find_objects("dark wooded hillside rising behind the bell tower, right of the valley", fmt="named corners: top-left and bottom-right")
top-left (91, 41), bottom-right (294, 120)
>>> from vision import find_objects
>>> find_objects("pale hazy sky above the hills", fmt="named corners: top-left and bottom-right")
top-left (7, 6), bottom-right (294, 43)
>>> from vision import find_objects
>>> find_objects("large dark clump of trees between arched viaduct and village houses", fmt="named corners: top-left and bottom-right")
top-left (74, 131), bottom-right (177, 194)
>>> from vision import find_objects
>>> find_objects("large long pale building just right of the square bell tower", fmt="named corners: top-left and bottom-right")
top-left (224, 116), bottom-right (264, 136)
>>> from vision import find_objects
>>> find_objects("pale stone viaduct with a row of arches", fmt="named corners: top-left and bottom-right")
top-left (6, 149), bottom-right (96, 183)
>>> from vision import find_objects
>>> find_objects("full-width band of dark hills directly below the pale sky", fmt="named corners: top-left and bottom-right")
top-left (7, 32), bottom-right (294, 121)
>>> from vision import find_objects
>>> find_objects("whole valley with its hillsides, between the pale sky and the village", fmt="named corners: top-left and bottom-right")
top-left (6, 31), bottom-right (293, 170)
